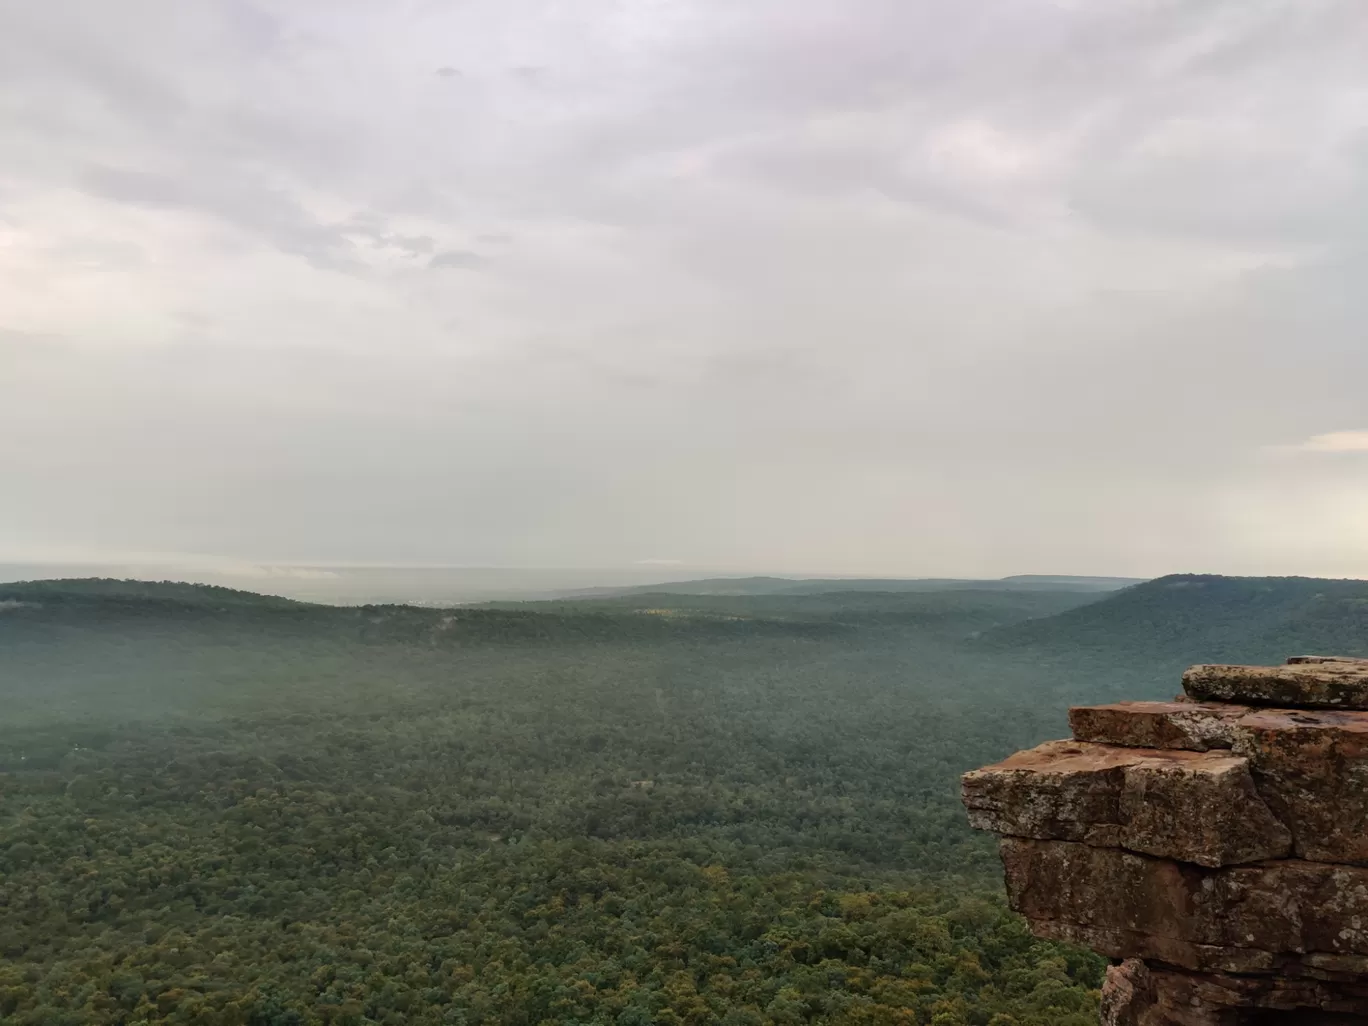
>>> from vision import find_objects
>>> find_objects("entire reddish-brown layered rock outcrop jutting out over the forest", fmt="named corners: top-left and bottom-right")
top-left (963, 657), bottom-right (1368, 1026)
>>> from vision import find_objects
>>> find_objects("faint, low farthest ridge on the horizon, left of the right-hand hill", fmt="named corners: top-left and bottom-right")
top-left (572, 573), bottom-right (1142, 598)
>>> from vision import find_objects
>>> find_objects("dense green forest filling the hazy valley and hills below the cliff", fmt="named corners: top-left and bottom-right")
top-left (0, 577), bottom-right (1368, 1026)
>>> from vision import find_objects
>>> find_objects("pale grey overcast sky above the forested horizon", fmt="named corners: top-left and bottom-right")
top-left (0, 0), bottom-right (1368, 577)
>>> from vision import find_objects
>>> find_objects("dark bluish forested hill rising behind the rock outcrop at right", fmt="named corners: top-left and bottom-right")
top-left (981, 573), bottom-right (1368, 665)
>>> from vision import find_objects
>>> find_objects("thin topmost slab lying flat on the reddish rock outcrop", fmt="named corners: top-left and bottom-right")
top-left (1183, 655), bottom-right (1368, 710)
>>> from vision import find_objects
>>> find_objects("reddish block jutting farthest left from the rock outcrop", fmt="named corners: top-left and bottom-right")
top-left (963, 741), bottom-right (1291, 866)
